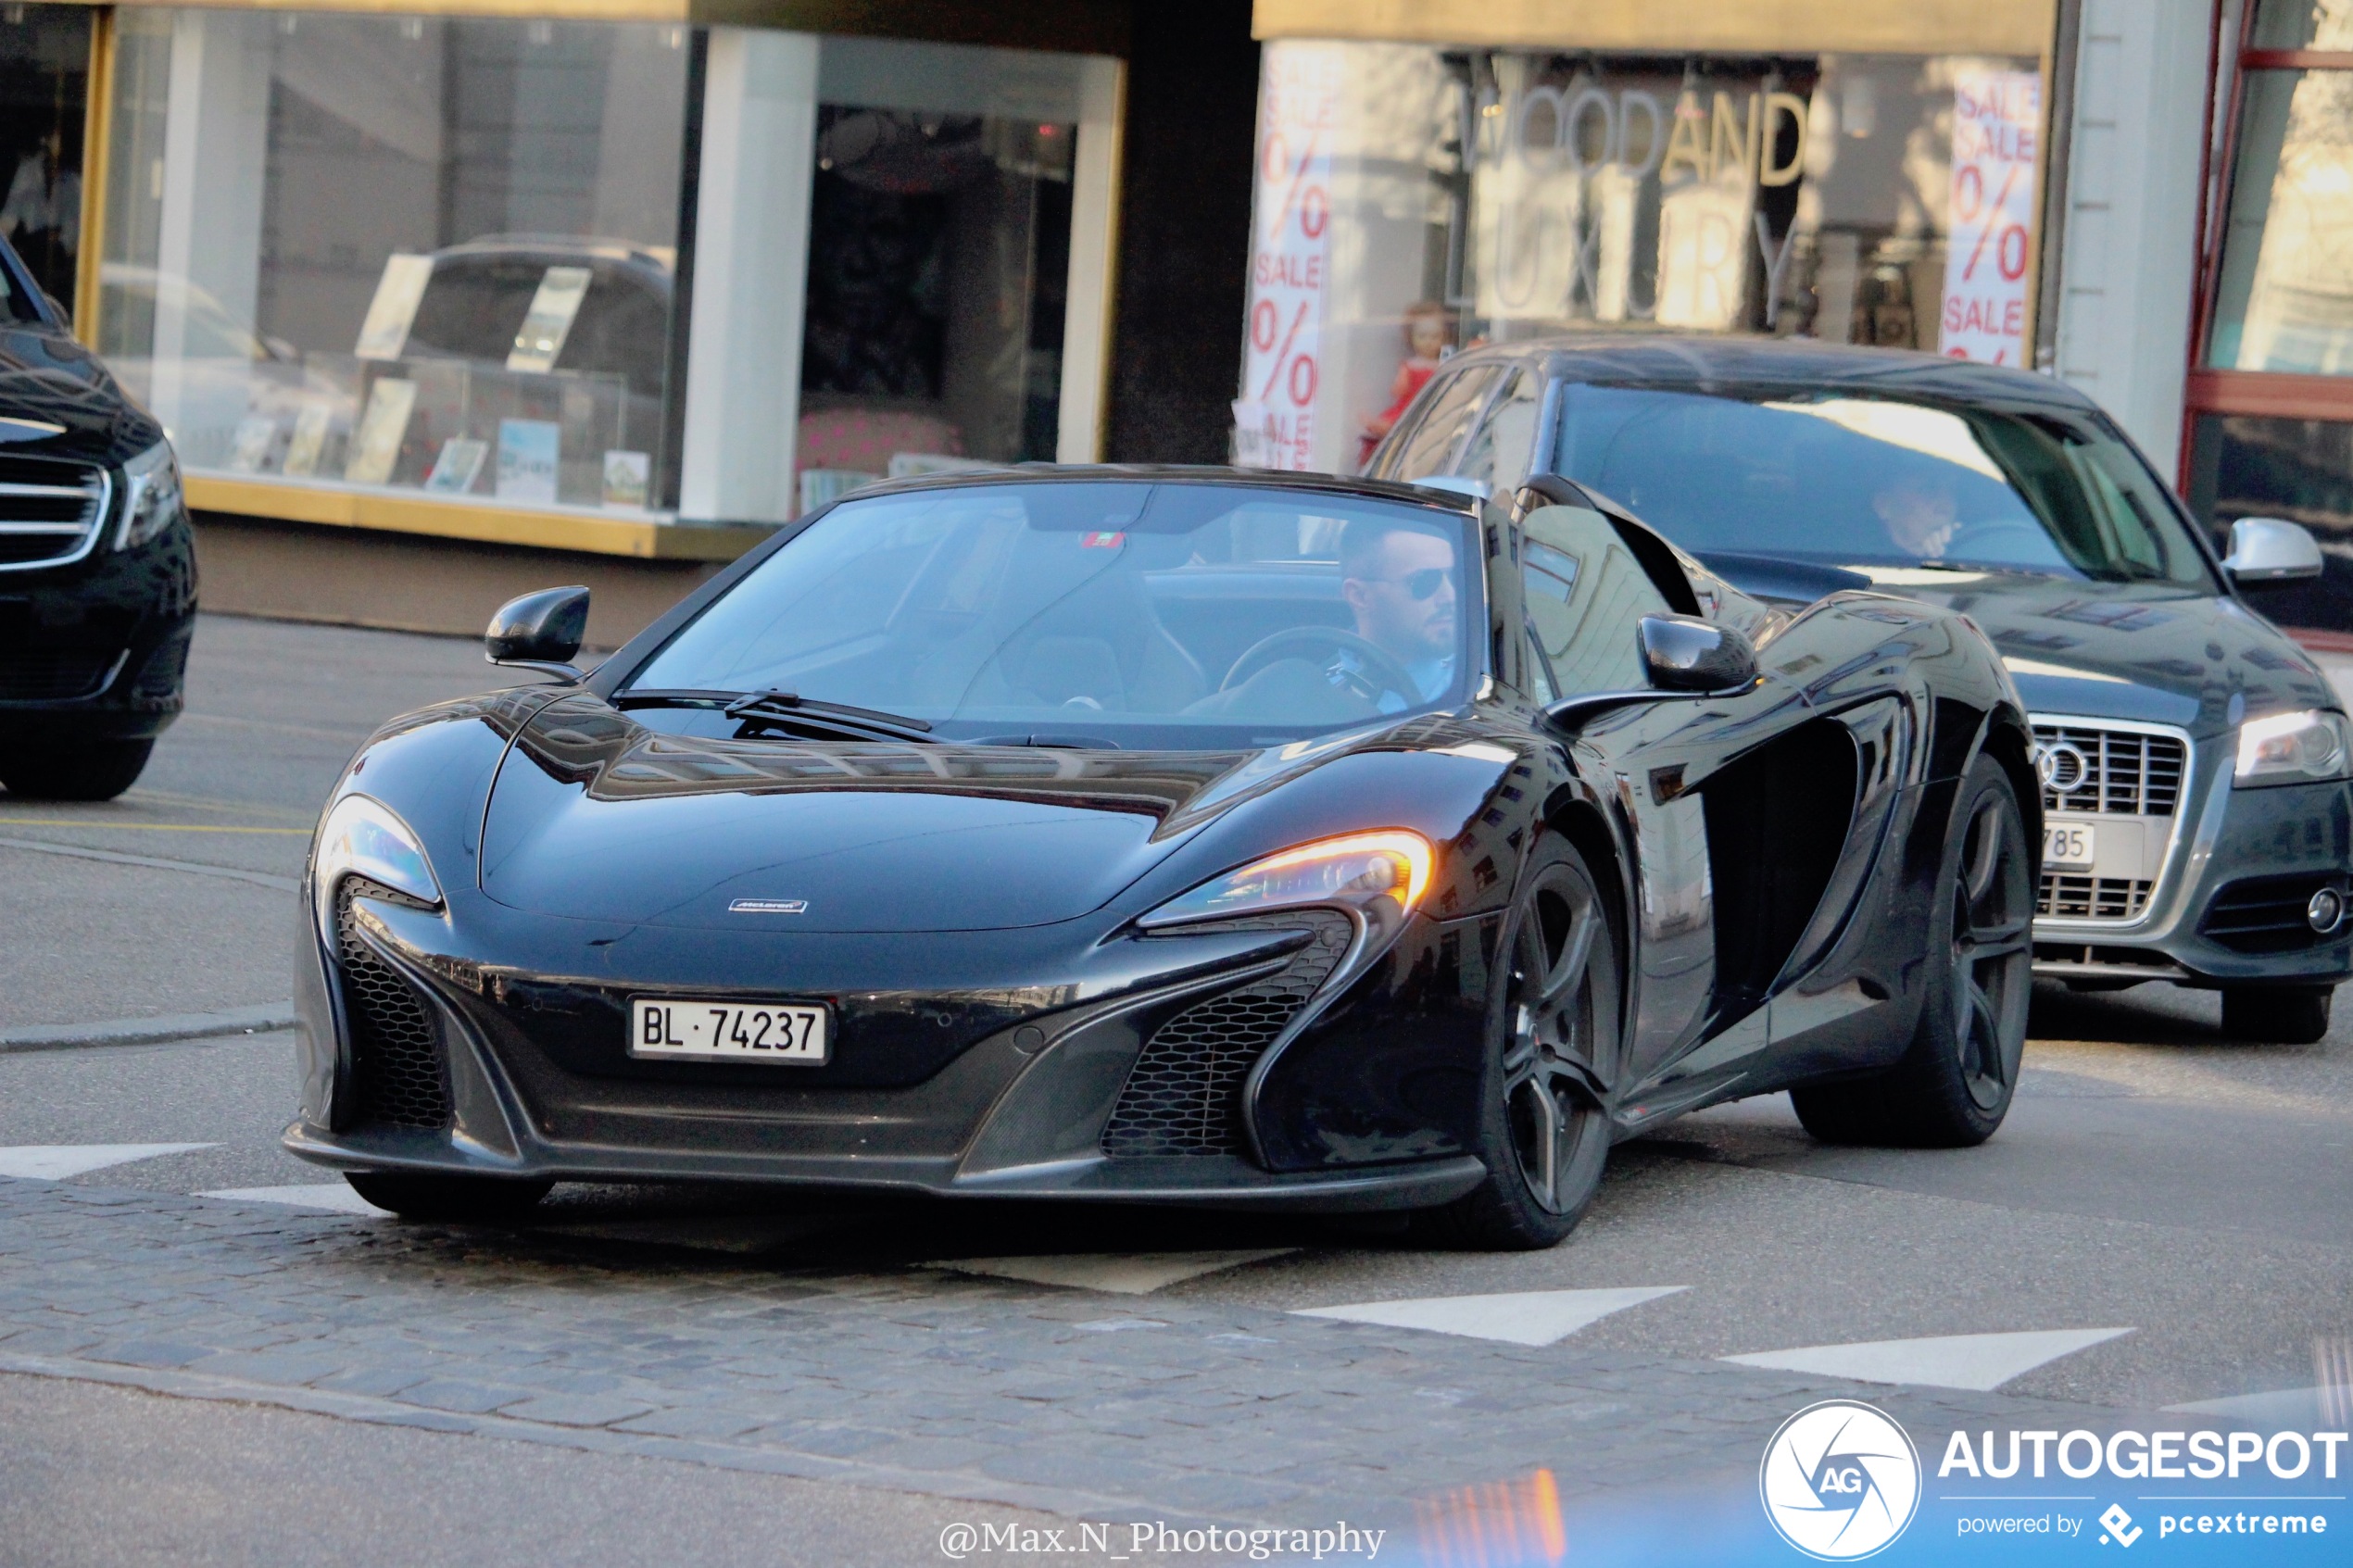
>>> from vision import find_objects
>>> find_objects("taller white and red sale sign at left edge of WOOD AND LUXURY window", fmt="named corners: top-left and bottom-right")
top-left (1233, 43), bottom-right (1343, 470)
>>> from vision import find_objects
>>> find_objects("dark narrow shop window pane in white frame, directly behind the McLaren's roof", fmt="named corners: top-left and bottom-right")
top-left (796, 40), bottom-right (1080, 510)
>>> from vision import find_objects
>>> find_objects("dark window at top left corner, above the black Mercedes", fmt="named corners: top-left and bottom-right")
top-left (0, 5), bottom-right (92, 310)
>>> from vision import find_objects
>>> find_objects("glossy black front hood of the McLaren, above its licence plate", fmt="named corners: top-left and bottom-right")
top-left (483, 698), bottom-right (1254, 931)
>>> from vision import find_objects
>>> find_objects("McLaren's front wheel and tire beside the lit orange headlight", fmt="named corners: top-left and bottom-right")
top-left (1426, 839), bottom-right (1621, 1250)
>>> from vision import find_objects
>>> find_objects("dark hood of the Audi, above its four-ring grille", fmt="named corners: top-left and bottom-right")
top-left (1859, 567), bottom-right (2341, 738)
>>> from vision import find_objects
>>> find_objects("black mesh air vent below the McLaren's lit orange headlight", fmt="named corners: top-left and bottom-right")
top-left (1103, 909), bottom-right (1355, 1159)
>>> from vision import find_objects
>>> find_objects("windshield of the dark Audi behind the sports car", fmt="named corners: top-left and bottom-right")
top-left (1557, 385), bottom-right (2217, 593)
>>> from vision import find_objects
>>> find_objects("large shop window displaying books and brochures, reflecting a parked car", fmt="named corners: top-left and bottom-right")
top-left (99, 9), bottom-right (689, 512)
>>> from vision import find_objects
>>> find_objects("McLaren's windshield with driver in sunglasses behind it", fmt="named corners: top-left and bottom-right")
top-left (614, 480), bottom-right (1478, 747)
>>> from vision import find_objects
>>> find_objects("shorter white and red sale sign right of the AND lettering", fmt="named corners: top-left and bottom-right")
top-left (1942, 69), bottom-right (2043, 364)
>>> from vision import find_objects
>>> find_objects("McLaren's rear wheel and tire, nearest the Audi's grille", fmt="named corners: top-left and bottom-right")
top-left (1791, 757), bottom-right (2035, 1149)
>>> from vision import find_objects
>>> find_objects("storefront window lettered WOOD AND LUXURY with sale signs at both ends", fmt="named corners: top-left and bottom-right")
top-left (1236, 43), bottom-right (2043, 470)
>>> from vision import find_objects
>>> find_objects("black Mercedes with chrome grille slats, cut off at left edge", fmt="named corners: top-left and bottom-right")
top-left (0, 240), bottom-right (195, 799)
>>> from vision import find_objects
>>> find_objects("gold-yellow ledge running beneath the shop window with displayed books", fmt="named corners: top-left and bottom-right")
top-left (186, 475), bottom-right (770, 562)
